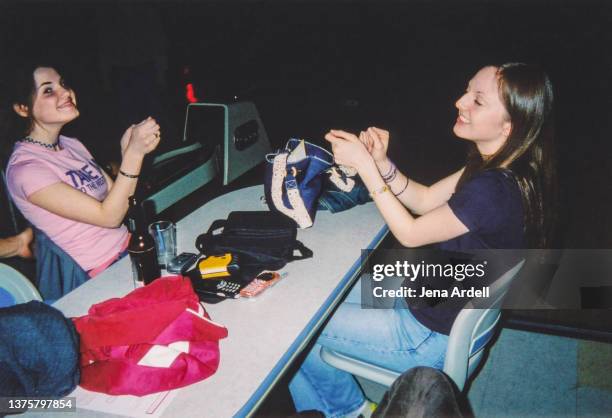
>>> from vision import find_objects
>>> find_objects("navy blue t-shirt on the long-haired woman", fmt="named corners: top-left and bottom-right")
top-left (408, 170), bottom-right (526, 335)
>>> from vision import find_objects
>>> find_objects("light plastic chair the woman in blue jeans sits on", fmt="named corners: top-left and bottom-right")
top-left (321, 260), bottom-right (525, 390)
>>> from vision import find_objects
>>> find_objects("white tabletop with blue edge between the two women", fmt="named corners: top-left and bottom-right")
top-left (47, 186), bottom-right (388, 418)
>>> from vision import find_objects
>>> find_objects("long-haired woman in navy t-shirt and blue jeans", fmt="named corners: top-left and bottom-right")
top-left (289, 63), bottom-right (555, 417)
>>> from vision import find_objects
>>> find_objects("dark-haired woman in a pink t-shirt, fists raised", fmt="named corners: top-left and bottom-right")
top-left (7, 65), bottom-right (160, 277)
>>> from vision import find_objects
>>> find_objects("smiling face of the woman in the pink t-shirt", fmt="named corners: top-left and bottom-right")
top-left (15, 67), bottom-right (79, 138)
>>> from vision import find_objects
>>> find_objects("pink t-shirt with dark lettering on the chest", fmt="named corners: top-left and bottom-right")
top-left (6, 136), bottom-right (128, 271)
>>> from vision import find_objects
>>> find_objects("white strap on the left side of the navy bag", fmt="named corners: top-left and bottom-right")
top-left (270, 153), bottom-right (312, 228)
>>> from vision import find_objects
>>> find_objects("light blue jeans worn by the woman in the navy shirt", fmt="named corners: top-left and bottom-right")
top-left (289, 283), bottom-right (448, 417)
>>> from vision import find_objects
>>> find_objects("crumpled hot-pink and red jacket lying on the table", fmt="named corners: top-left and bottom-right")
top-left (73, 276), bottom-right (227, 396)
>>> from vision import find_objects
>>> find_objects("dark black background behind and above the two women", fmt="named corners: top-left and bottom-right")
top-left (0, 1), bottom-right (612, 248)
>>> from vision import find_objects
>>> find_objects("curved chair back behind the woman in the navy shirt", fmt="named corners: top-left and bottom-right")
top-left (443, 260), bottom-right (525, 390)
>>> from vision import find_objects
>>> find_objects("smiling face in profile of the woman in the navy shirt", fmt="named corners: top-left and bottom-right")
top-left (453, 67), bottom-right (512, 155)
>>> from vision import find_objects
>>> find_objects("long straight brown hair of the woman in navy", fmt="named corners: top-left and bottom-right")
top-left (457, 63), bottom-right (557, 248)
